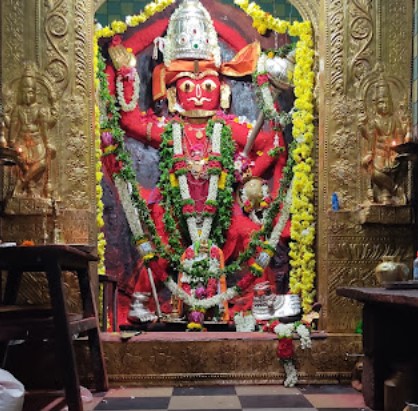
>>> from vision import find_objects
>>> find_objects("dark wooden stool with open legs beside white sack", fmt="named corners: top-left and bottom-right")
top-left (0, 245), bottom-right (108, 411)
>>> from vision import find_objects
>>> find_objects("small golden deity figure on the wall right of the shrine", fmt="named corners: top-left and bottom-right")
top-left (360, 76), bottom-right (408, 205)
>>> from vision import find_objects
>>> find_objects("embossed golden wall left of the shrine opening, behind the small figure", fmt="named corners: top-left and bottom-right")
top-left (0, 0), bottom-right (96, 302)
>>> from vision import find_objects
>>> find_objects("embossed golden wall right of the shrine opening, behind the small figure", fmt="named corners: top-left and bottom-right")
top-left (318, 0), bottom-right (414, 332)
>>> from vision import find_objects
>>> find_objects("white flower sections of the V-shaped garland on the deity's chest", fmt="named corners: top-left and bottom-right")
top-left (173, 122), bottom-right (223, 243)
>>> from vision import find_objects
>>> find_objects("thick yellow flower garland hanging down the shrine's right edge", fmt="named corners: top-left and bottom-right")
top-left (235, 0), bottom-right (315, 314)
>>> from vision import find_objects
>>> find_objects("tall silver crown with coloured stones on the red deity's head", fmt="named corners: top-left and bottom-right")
top-left (156, 0), bottom-right (221, 66)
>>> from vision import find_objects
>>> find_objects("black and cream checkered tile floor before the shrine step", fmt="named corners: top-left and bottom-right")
top-left (24, 385), bottom-right (368, 411)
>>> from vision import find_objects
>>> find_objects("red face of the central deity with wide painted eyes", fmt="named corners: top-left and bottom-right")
top-left (176, 75), bottom-right (221, 111)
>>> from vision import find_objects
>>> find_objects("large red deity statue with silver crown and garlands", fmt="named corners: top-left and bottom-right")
top-left (103, 0), bottom-right (300, 321)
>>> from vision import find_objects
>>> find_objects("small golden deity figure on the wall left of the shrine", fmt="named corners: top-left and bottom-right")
top-left (9, 64), bottom-right (57, 198)
